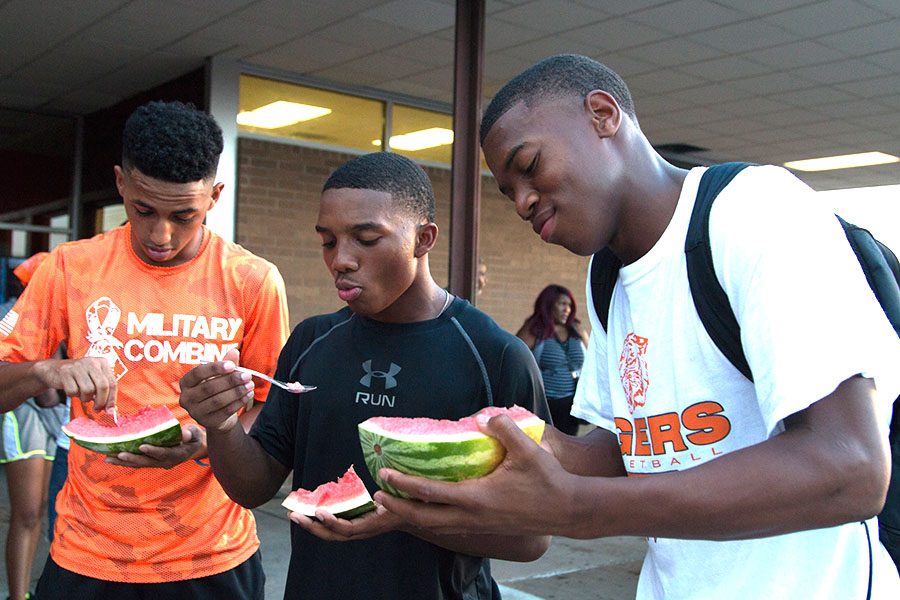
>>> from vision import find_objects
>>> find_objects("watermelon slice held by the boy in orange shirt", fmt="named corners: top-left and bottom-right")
top-left (63, 406), bottom-right (181, 455)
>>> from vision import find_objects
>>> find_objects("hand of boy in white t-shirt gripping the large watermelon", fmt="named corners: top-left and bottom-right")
top-left (375, 415), bottom-right (574, 535)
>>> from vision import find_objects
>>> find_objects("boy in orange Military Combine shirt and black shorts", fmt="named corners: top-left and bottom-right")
top-left (0, 102), bottom-right (288, 600)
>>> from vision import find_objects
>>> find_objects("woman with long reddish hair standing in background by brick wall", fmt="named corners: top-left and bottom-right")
top-left (516, 284), bottom-right (588, 435)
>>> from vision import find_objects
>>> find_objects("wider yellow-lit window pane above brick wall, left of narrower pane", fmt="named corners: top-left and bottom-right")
top-left (237, 75), bottom-right (384, 152)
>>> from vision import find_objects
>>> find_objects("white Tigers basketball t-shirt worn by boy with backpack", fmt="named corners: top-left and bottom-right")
top-left (572, 167), bottom-right (900, 599)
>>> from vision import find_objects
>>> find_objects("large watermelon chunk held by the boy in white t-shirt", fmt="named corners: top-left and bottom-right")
top-left (359, 406), bottom-right (544, 498)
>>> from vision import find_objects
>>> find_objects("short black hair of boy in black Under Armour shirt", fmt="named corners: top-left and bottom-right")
top-left (322, 152), bottom-right (435, 223)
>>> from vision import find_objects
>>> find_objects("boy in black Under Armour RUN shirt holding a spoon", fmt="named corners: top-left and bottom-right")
top-left (181, 152), bottom-right (549, 600)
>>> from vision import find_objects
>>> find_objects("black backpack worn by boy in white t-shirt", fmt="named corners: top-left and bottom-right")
top-left (590, 163), bottom-right (900, 585)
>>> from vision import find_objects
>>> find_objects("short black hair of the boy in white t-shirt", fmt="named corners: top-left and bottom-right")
top-left (479, 54), bottom-right (637, 144)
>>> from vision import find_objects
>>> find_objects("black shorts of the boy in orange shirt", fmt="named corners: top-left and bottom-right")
top-left (34, 550), bottom-right (266, 600)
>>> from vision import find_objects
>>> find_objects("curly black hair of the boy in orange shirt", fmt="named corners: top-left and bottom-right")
top-left (122, 101), bottom-right (223, 183)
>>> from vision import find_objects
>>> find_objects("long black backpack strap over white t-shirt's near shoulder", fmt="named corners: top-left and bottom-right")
top-left (684, 162), bottom-right (753, 381)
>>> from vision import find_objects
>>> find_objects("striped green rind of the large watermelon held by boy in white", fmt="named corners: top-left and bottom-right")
top-left (358, 417), bottom-right (544, 498)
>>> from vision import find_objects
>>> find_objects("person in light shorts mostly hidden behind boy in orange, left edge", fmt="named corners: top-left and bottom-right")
top-left (0, 252), bottom-right (66, 600)
